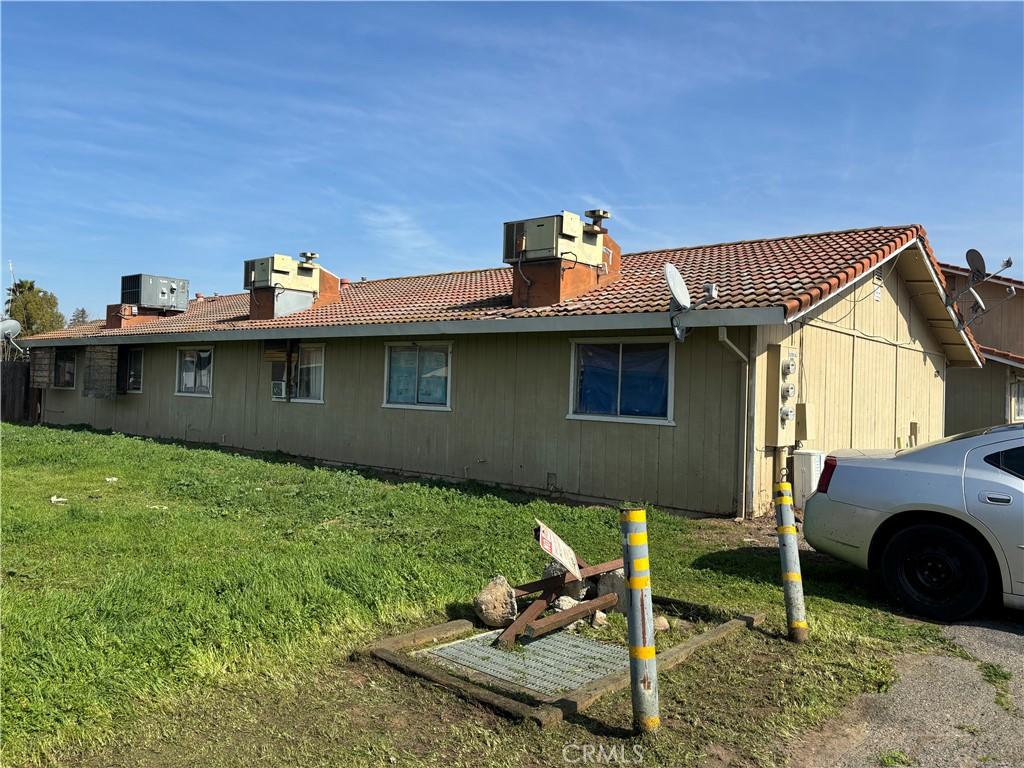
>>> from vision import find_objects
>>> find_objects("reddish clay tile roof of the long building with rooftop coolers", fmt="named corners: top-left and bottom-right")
top-left (25, 224), bottom-right (958, 339)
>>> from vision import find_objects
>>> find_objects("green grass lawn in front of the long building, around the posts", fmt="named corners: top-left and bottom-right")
top-left (0, 425), bottom-right (958, 766)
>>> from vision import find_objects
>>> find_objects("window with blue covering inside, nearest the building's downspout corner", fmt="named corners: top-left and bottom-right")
top-left (569, 339), bottom-right (674, 423)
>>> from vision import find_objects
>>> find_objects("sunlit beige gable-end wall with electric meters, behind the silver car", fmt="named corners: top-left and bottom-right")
top-left (754, 260), bottom-right (945, 514)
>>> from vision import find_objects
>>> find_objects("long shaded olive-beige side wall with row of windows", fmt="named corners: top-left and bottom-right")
top-left (43, 329), bottom-right (750, 514)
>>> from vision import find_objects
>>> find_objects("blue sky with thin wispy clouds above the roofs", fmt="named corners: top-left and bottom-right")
top-left (2, 3), bottom-right (1024, 316)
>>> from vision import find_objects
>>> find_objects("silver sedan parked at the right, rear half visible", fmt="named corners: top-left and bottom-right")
top-left (804, 424), bottom-right (1024, 622)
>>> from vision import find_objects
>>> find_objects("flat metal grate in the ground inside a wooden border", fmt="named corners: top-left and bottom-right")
top-left (420, 631), bottom-right (630, 696)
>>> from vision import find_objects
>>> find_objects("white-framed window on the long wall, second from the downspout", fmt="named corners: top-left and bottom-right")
top-left (384, 344), bottom-right (452, 410)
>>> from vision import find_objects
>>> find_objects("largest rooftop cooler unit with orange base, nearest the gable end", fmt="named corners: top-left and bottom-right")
top-left (505, 209), bottom-right (622, 307)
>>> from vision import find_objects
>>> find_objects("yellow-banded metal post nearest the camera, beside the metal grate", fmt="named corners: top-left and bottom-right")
top-left (618, 505), bottom-right (662, 732)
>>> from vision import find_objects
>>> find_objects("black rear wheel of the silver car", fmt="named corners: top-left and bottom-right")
top-left (882, 525), bottom-right (988, 622)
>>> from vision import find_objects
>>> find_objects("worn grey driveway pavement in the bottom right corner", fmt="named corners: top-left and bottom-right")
top-left (791, 611), bottom-right (1024, 768)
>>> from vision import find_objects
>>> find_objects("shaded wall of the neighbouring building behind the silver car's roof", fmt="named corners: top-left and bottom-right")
top-left (946, 360), bottom-right (1024, 434)
